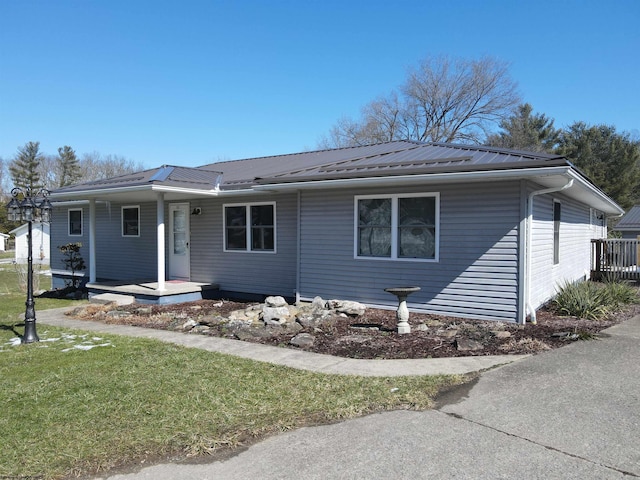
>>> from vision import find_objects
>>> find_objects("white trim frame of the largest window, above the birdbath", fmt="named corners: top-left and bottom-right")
top-left (353, 192), bottom-right (440, 263)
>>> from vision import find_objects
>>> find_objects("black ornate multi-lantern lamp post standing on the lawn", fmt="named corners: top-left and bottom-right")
top-left (7, 187), bottom-right (52, 343)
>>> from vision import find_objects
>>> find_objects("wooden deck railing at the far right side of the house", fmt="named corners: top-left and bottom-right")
top-left (591, 238), bottom-right (640, 281)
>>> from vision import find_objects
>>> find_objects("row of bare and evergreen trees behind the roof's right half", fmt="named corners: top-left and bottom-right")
top-left (318, 56), bottom-right (640, 209)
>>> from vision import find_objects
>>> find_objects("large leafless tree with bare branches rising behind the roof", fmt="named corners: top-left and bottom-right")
top-left (320, 56), bottom-right (520, 148)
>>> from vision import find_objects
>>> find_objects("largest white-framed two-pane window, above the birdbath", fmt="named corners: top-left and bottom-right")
top-left (355, 193), bottom-right (440, 261)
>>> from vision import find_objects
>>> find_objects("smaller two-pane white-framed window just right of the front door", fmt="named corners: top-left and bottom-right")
top-left (224, 203), bottom-right (276, 252)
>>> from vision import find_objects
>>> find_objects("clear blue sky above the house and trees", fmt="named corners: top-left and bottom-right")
top-left (0, 0), bottom-right (640, 168)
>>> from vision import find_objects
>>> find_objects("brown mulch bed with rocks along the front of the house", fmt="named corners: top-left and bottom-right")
top-left (66, 300), bottom-right (640, 359)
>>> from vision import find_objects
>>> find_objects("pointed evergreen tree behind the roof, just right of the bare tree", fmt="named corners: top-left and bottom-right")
top-left (485, 103), bottom-right (560, 153)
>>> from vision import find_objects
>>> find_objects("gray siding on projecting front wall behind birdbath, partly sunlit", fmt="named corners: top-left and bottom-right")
top-left (300, 182), bottom-right (520, 321)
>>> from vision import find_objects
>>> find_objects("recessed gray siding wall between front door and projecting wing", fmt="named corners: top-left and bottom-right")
top-left (191, 193), bottom-right (298, 297)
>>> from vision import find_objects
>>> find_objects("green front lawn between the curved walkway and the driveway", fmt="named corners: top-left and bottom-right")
top-left (0, 265), bottom-right (465, 478)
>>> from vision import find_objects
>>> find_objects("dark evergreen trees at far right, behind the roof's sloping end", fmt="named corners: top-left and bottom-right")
top-left (557, 122), bottom-right (640, 209)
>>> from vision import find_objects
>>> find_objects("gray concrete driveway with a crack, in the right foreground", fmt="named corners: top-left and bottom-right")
top-left (96, 317), bottom-right (640, 480)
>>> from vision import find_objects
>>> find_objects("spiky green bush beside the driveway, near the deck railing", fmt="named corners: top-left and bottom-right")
top-left (553, 281), bottom-right (638, 320)
